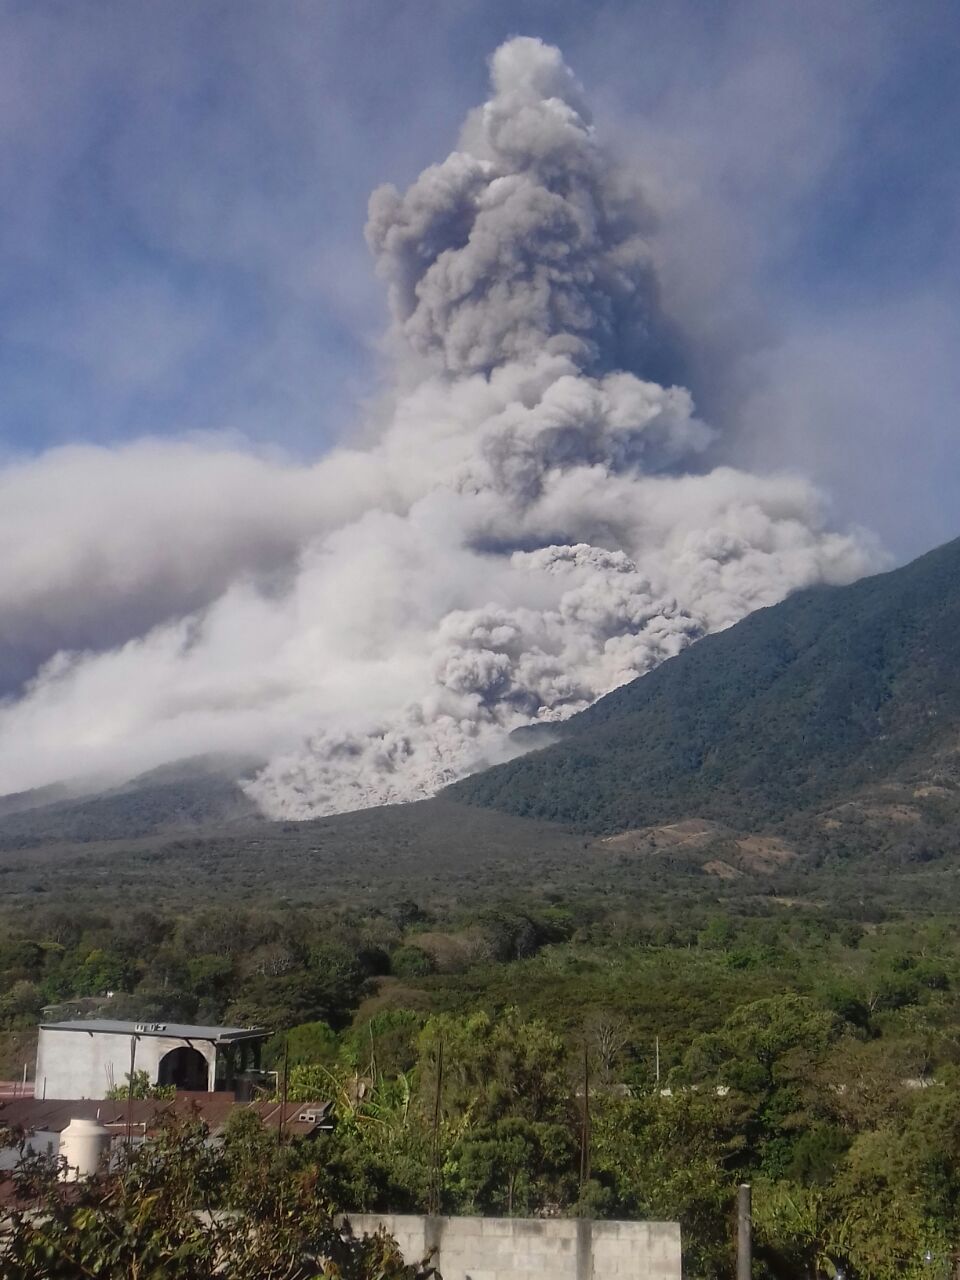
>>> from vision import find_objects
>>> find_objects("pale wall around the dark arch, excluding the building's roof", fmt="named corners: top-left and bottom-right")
top-left (33, 1027), bottom-right (216, 1098)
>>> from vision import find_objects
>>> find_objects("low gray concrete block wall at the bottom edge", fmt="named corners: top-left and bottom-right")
top-left (348, 1213), bottom-right (680, 1280)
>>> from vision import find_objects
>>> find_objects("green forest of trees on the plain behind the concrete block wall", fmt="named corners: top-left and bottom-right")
top-left (0, 873), bottom-right (960, 1280)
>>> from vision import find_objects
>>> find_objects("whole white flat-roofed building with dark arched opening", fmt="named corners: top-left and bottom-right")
top-left (33, 1019), bottom-right (268, 1100)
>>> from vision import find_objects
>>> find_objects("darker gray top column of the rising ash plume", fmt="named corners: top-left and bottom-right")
top-left (367, 40), bottom-right (654, 376)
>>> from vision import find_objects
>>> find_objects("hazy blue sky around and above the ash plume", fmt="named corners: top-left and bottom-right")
top-left (0, 0), bottom-right (960, 558)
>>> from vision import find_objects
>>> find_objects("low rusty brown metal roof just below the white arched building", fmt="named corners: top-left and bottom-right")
top-left (0, 1092), bottom-right (333, 1135)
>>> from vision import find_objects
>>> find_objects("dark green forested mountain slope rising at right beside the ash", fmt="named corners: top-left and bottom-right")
top-left (449, 539), bottom-right (960, 832)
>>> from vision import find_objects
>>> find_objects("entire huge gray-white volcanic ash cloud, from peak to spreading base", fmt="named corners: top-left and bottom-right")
top-left (0, 38), bottom-right (874, 818)
